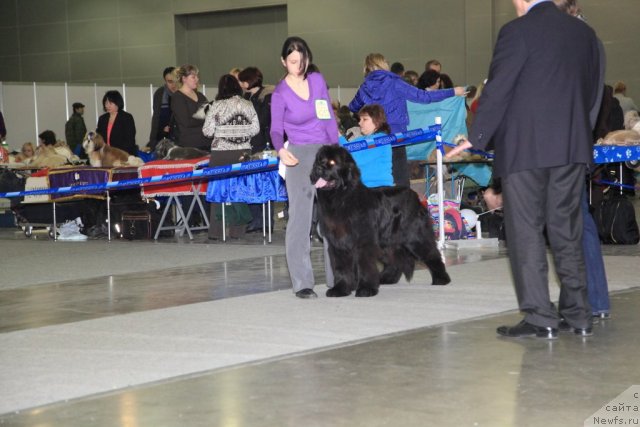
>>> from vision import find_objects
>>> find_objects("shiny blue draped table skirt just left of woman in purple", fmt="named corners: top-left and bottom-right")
top-left (207, 170), bottom-right (287, 203)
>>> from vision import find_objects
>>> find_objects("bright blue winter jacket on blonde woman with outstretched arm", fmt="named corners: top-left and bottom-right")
top-left (349, 70), bottom-right (455, 133)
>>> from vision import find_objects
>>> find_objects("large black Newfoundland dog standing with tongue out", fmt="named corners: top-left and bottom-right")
top-left (310, 145), bottom-right (451, 297)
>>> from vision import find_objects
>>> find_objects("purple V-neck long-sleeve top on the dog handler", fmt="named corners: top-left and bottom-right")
top-left (271, 73), bottom-right (338, 151)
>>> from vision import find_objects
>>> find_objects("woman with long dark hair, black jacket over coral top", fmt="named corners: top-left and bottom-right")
top-left (96, 90), bottom-right (138, 156)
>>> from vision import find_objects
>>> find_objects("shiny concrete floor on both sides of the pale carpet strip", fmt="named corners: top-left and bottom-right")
top-left (0, 216), bottom-right (640, 427)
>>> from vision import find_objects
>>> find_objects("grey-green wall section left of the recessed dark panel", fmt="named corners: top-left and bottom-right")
top-left (0, 0), bottom-right (175, 85)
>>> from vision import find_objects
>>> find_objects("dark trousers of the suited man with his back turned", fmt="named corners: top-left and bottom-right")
top-left (502, 164), bottom-right (591, 328)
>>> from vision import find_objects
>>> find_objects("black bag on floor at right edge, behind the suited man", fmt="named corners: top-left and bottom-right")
top-left (593, 191), bottom-right (640, 245)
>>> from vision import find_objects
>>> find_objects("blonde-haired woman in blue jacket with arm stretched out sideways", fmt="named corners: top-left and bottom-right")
top-left (349, 53), bottom-right (465, 187)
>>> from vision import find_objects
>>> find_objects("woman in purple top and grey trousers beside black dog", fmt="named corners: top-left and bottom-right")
top-left (271, 37), bottom-right (338, 298)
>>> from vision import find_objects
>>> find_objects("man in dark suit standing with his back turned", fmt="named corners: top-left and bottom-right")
top-left (448, 0), bottom-right (601, 339)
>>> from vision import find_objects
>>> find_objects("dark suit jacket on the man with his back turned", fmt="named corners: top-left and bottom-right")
top-left (469, 2), bottom-right (601, 176)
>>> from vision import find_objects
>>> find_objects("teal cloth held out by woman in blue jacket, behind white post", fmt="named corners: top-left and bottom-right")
top-left (407, 96), bottom-right (491, 187)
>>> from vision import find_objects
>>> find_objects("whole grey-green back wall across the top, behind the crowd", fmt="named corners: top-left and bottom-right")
top-left (0, 0), bottom-right (640, 150)
